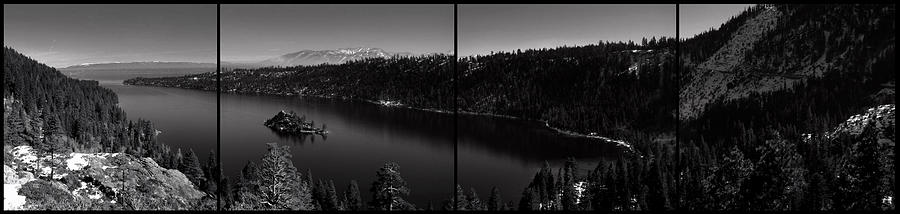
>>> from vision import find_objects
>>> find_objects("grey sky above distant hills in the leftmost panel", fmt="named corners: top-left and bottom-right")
top-left (3, 5), bottom-right (216, 67)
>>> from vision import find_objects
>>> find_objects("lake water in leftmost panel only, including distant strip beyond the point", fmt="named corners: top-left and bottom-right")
top-left (61, 68), bottom-right (217, 172)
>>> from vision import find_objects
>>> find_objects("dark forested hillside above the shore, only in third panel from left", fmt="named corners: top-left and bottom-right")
top-left (458, 37), bottom-right (676, 141)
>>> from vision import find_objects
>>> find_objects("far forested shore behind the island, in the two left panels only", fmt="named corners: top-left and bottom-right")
top-left (125, 55), bottom-right (453, 109)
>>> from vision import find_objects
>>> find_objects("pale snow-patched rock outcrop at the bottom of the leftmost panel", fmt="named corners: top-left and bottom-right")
top-left (3, 146), bottom-right (209, 210)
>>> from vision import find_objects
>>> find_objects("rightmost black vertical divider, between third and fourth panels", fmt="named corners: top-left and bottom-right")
top-left (675, 4), bottom-right (682, 210)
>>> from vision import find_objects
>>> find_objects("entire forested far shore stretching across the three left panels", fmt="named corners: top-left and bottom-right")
top-left (125, 37), bottom-right (676, 142)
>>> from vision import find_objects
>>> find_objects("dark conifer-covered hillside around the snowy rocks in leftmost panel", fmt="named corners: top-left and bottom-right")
top-left (3, 47), bottom-right (216, 209)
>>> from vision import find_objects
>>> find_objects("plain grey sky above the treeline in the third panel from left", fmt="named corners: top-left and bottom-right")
top-left (458, 4), bottom-right (675, 56)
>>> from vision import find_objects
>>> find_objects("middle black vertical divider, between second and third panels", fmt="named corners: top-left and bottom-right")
top-left (450, 3), bottom-right (459, 210)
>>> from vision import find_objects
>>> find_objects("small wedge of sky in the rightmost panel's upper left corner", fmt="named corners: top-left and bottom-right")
top-left (678, 4), bottom-right (752, 39)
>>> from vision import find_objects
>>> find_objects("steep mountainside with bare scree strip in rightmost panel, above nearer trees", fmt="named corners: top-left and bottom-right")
top-left (679, 5), bottom-right (894, 120)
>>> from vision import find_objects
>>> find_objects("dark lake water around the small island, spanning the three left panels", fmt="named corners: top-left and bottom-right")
top-left (68, 70), bottom-right (620, 208)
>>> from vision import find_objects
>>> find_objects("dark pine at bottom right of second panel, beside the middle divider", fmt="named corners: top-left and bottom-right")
top-left (369, 162), bottom-right (415, 211)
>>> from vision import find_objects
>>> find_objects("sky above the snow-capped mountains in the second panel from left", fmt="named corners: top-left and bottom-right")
top-left (221, 4), bottom-right (453, 61)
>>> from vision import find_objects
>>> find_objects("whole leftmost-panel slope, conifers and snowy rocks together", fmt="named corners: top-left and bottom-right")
top-left (3, 48), bottom-right (212, 210)
